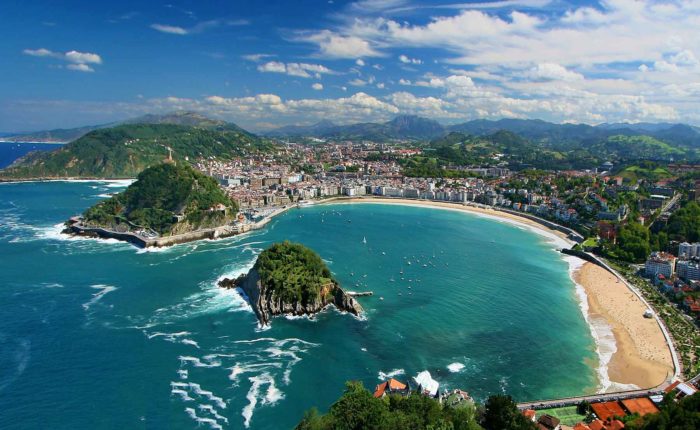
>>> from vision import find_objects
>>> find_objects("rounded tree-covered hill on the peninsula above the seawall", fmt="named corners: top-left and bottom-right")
top-left (83, 163), bottom-right (238, 235)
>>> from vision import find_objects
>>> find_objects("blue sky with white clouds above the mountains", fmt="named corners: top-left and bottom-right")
top-left (0, 0), bottom-right (700, 132)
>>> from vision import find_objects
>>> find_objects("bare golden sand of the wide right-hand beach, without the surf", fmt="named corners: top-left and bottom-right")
top-left (574, 263), bottom-right (673, 389)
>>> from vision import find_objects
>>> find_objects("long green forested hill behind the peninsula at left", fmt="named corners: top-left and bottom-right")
top-left (0, 123), bottom-right (273, 179)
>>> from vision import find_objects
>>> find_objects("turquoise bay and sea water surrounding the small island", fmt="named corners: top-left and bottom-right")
top-left (0, 182), bottom-right (597, 429)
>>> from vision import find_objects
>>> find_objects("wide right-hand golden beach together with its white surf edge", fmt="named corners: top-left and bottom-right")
top-left (571, 262), bottom-right (674, 393)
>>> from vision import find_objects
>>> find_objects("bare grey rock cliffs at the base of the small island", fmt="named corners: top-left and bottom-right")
top-left (219, 267), bottom-right (362, 325)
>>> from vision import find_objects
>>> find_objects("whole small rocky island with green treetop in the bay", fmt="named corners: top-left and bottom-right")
top-left (219, 241), bottom-right (362, 325)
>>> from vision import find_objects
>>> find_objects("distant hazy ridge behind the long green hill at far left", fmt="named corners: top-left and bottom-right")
top-left (2, 111), bottom-right (244, 143)
